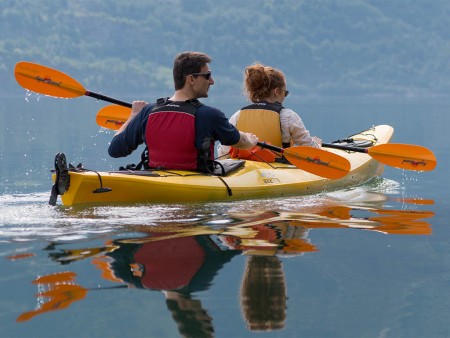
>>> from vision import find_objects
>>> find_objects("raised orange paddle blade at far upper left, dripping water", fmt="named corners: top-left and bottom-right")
top-left (14, 61), bottom-right (86, 99)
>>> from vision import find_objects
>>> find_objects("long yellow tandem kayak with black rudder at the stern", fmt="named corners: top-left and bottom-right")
top-left (50, 125), bottom-right (394, 206)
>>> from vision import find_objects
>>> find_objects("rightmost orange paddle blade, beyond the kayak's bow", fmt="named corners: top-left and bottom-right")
top-left (368, 143), bottom-right (437, 171)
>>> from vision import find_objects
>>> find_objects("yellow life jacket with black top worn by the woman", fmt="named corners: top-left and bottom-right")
top-left (236, 102), bottom-right (283, 147)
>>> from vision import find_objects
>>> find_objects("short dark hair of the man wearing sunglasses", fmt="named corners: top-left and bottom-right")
top-left (173, 52), bottom-right (212, 90)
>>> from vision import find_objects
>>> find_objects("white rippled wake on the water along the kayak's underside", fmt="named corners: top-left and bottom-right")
top-left (0, 178), bottom-right (432, 241)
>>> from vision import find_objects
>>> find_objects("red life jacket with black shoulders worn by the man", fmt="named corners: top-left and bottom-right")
top-left (145, 98), bottom-right (214, 171)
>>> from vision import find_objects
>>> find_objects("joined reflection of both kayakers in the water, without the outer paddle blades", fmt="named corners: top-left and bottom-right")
top-left (39, 219), bottom-right (315, 337)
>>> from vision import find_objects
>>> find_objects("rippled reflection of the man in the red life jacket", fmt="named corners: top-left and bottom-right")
top-left (96, 233), bottom-right (239, 337)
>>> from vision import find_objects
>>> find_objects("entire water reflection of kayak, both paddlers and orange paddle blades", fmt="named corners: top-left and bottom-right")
top-left (17, 205), bottom-right (434, 337)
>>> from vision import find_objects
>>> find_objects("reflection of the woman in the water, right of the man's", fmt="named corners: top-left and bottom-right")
top-left (222, 218), bottom-right (317, 331)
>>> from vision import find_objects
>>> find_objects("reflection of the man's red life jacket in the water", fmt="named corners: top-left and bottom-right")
top-left (92, 232), bottom-right (207, 290)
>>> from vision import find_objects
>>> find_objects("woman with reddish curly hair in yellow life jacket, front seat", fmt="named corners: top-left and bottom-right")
top-left (218, 63), bottom-right (322, 157)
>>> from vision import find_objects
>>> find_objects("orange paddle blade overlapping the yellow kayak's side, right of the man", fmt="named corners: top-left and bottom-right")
top-left (284, 146), bottom-right (350, 179)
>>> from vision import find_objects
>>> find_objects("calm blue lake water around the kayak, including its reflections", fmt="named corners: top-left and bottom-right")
top-left (0, 94), bottom-right (450, 337)
